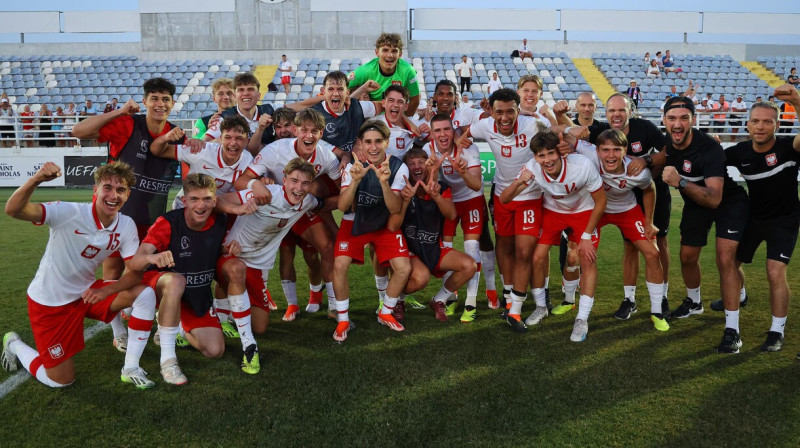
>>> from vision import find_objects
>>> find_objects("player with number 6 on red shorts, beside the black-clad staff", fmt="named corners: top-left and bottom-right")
top-left (576, 129), bottom-right (669, 331)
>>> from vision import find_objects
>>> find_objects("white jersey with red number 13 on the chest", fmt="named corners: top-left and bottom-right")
top-left (470, 116), bottom-right (544, 201)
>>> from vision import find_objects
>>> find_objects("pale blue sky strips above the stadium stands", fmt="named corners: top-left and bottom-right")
top-left (0, 0), bottom-right (800, 44)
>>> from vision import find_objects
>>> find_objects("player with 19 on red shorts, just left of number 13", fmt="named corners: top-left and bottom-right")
top-left (424, 114), bottom-right (488, 322)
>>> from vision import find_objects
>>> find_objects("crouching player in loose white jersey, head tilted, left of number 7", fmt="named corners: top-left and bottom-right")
top-left (223, 157), bottom-right (337, 334)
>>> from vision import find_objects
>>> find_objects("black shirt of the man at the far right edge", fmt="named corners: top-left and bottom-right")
top-left (725, 136), bottom-right (800, 220)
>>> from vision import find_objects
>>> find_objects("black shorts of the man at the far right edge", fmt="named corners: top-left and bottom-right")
top-left (736, 217), bottom-right (800, 264)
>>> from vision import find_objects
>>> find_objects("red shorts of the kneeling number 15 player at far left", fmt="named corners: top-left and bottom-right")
top-left (28, 280), bottom-right (117, 369)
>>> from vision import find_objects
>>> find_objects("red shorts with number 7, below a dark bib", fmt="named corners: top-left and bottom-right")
top-left (333, 219), bottom-right (408, 265)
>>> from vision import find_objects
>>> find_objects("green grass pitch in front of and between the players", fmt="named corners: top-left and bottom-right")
top-left (0, 189), bottom-right (800, 447)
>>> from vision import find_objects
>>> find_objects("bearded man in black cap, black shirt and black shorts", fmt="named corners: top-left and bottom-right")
top-left (654, 96), bottom-right (748, 353)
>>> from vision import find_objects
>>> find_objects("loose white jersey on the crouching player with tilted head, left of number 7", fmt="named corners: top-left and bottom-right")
top-left (225, 185), bottom-right (319, 270)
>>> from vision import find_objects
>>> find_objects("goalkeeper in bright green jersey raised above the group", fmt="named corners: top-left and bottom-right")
top-left (347, 33), bottom-right (420, 117)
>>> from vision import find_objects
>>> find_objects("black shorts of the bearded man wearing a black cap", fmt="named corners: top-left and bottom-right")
top-left (680, 192), bottom-right (750, 247)
